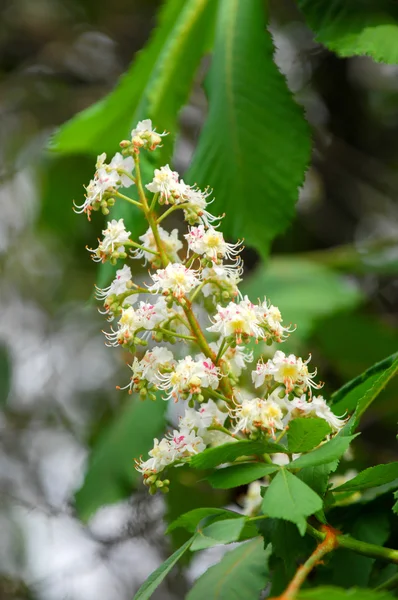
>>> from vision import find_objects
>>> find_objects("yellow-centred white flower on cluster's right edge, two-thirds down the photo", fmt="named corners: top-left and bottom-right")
top-left (252, 350), bottom-right (321, 392)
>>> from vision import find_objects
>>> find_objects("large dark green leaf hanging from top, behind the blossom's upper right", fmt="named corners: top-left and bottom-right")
top-left (188, 0), bottom-right (311, 255)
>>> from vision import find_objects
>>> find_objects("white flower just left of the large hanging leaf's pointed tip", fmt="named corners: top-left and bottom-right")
top-left (184, 225), bottom-right (241, 262)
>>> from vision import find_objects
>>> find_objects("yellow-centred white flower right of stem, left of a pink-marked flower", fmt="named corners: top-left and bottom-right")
top-left (207, 296), bottom-right (264, 342)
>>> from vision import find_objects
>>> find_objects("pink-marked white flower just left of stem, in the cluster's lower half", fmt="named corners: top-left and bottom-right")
top-left (158, 355), bottom-right (221, 402)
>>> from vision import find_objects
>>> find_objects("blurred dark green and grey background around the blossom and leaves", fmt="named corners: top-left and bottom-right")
top-left (0, 0), bottom-right (398, 600)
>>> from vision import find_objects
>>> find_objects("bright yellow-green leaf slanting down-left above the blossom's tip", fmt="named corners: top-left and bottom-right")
top-left (51, 0), bottom-right (216, 156)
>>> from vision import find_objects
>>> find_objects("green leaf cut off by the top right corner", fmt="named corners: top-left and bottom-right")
top-left (298, 0), bottom-right (398, 64)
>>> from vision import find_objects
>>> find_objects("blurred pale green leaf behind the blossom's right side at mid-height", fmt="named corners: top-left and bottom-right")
top-left (241, 256), bottom-right (362, 343)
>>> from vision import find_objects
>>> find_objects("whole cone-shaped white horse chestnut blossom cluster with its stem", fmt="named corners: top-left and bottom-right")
top-left (75, 119), bottom-right (346, 493)
